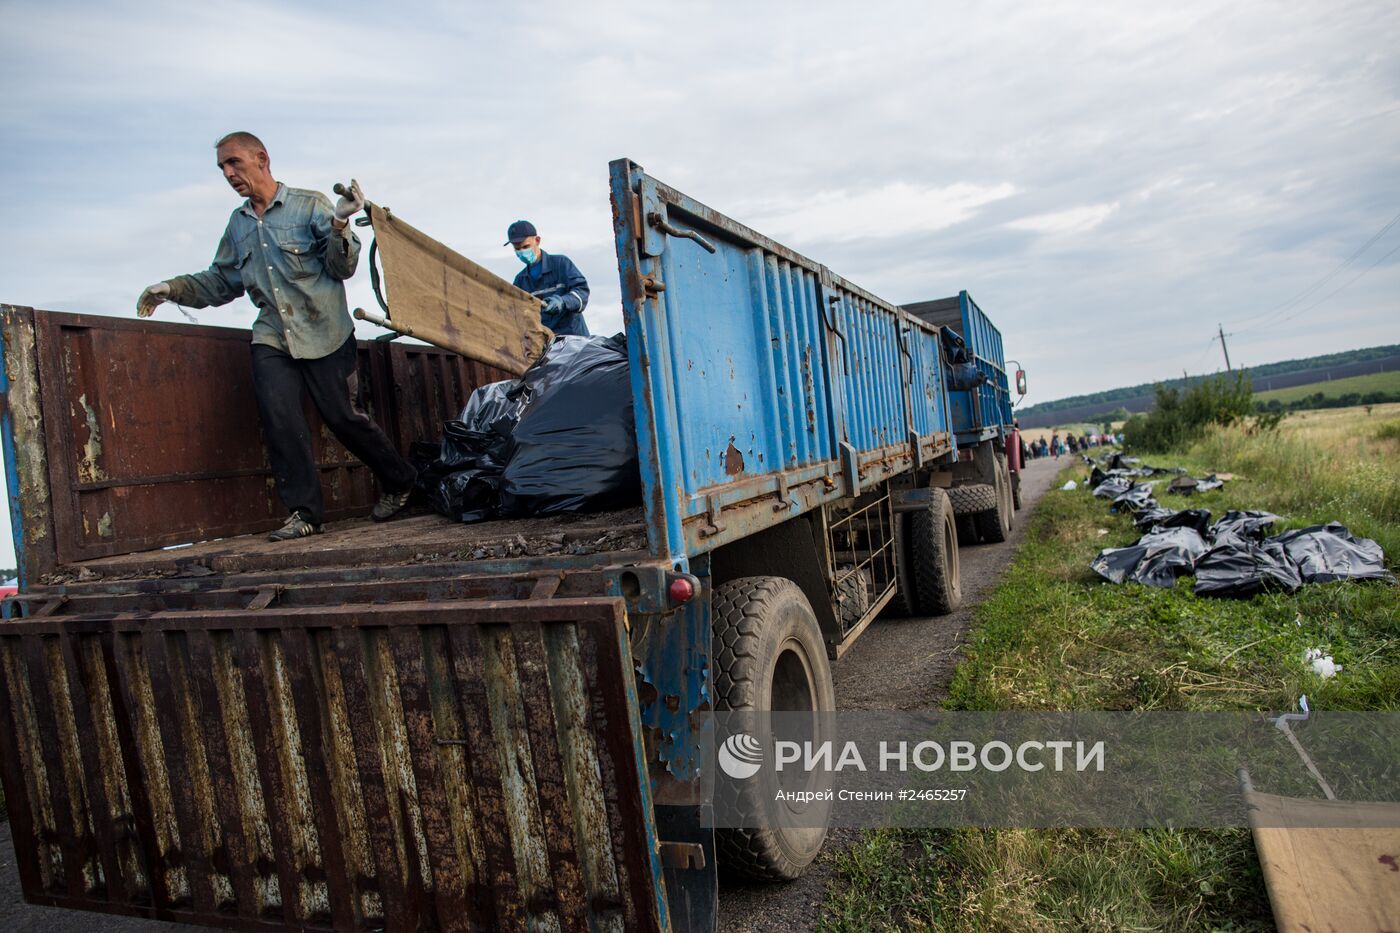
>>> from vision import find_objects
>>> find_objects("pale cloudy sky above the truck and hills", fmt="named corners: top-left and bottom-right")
top-left (0, 0), bottom-right (1400, 562)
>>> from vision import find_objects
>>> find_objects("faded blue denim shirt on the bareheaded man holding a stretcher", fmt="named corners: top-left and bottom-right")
top-left (169, 182), bottom-right (360, 360)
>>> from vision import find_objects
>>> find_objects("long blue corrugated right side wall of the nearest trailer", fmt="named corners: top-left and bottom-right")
top-left (610, 160), bottom-right (952, 566)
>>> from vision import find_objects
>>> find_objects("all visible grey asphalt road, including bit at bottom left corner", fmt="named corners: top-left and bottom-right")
top-left (0, 459), bottom-right (1068, 933)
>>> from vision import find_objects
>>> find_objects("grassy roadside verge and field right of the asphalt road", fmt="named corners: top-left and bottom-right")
top-left (825, 405), bottom-right (1400, 930)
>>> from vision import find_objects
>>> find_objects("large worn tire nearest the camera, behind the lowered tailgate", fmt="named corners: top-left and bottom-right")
top-left (711, 577), bottom-right (836, 881)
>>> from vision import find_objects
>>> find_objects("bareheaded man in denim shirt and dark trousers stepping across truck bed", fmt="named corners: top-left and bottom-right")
top-left (136, 133), bottom-right (417, 541)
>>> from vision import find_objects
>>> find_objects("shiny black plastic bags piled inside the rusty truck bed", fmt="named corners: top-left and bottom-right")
top-left (414, 336), bottom-right (641, 521)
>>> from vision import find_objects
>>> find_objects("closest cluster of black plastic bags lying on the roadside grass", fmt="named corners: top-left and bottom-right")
top-left (1089, 507), bottom-right (1394, 598)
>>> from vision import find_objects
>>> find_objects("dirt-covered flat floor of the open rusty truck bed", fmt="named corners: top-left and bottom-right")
top-left (31, 506), bottom-right (647, 586)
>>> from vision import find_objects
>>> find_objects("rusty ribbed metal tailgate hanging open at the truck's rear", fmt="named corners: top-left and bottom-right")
top-left (0, 597), bottom-right (669, 930)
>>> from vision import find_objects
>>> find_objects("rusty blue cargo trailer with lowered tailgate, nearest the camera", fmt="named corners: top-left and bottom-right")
top-left (0, 160), bottom-right (995, 930)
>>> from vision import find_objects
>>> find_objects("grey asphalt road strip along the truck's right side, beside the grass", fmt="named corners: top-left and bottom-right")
top-left (720, 458), bottom-right (1070, 933)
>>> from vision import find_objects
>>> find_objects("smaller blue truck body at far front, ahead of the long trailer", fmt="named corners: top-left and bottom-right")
top-left (903, 291), bottom-right (1025, 544)
